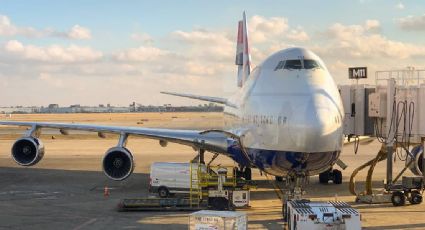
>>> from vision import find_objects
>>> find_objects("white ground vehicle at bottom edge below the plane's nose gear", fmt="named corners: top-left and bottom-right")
top-left (286, 200), bottom-right (362, 230)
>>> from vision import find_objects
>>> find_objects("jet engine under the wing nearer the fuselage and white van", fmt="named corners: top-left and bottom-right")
top-left (102, 147), bottom-right (134, 181)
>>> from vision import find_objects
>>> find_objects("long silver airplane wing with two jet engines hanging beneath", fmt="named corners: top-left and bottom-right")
top-left (0, 121), bottom-right (232, 180)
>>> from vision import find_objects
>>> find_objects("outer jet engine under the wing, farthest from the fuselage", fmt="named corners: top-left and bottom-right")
top-left (12, 137), bottom-right (44, 166)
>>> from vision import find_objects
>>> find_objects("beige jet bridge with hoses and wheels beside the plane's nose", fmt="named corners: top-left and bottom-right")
top-left (339, 68), bottom-right (425, 206)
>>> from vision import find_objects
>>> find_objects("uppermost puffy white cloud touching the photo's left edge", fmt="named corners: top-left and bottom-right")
top-left (0, 15), bottom-right (92, 40)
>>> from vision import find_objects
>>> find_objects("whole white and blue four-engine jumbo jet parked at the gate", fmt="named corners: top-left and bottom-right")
top-left (0, 13), bottom-right (344, 199)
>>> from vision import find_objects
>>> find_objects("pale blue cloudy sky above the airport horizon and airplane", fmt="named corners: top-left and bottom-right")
top-left (0, 0), bottom-right (425, 106)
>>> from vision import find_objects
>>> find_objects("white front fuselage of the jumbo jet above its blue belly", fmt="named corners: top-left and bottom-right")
top-left (225, 48), bottom-right (344, 175)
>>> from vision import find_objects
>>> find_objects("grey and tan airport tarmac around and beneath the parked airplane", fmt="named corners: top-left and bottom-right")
top-left (0, 113), bottom-right (425, 230)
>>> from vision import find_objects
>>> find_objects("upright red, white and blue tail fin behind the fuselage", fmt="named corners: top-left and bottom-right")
top-left (235, 12), bottom-right (251, 87)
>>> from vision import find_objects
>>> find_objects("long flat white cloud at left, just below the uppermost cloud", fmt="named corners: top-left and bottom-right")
top-left (3, 40), bottom-right (103, 63)
